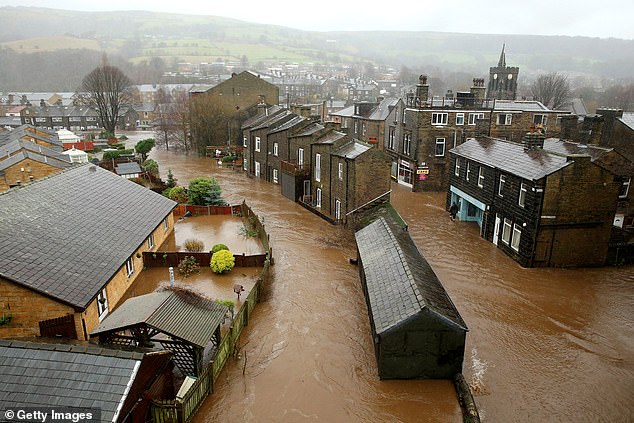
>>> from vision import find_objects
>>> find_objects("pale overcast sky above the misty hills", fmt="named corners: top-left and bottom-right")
top-left (0, 0), bottom-right (634, 39)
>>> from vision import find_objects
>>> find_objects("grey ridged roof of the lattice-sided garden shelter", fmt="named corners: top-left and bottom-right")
top-left (90, 291), bottom-right (228, 347)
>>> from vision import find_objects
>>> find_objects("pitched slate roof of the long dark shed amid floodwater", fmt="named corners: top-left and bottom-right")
top-left (355, 217), bottom-right (468, 334)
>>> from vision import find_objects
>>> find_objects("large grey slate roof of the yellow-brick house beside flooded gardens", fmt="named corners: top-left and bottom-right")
top-left (0, 164), bottom-right (176, 309)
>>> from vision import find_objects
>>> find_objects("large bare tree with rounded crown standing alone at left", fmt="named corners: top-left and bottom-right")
top-left (81, 64), bottom-right (134, 134)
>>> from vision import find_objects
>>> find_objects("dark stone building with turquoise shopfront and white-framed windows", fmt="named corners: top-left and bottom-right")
top-left (446, 133), bottom-right (623, 267)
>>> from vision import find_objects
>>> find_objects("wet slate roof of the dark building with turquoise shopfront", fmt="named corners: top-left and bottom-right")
top-left (450, 138), bottom-right (569, 181)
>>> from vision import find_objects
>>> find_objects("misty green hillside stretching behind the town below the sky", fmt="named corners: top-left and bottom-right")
top-left (0, 7), bottom-right (634, 90)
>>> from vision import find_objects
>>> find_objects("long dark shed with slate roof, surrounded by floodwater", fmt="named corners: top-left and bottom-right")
top-left (355, 218), bottom-right (468, 379)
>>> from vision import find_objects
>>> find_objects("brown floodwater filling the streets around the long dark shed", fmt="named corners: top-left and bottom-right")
top-left (143, 138), bottom-right (634, 423)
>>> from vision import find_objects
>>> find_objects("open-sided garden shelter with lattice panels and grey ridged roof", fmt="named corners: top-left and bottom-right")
top-left (90, 290), bottom-right (228, 376)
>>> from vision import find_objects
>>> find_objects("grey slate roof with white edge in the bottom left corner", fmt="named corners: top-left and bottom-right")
top-left (0, 339), bottom-right (143, 422)
